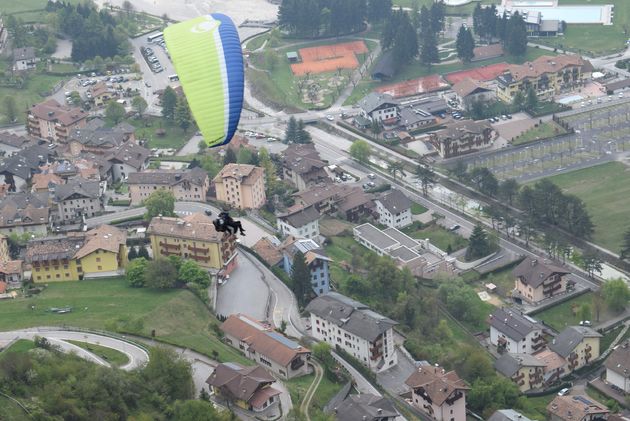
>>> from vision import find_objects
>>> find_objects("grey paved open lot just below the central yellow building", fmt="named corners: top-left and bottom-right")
top-left (216, 252), bottom-right (269, 320)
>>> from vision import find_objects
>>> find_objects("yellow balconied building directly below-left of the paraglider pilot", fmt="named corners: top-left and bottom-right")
top-left (147, 213), bottom-right (236, 274)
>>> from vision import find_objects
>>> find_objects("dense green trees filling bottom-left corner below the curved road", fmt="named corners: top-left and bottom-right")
top-left (0, 339), bottom-right (231, 421)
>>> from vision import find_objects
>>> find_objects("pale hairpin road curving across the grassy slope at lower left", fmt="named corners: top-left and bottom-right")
top-left (0, 328), bottom-right (149, 370)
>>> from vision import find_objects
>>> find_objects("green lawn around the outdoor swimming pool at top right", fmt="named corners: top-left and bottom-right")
top-left (535, 0), bottom-right (630, 56)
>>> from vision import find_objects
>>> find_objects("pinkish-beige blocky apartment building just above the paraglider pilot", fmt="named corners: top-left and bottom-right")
top-left (212, 164), bottom-right (267, 209)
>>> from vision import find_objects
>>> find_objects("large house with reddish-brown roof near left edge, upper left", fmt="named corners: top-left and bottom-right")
top-left (26, 99), bottom-right (88, 143)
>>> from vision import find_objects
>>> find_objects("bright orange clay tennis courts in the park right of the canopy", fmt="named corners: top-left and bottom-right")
top-left (291, 41), bottom-right (368, 76)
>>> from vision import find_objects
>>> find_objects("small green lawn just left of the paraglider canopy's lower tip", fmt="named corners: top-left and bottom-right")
top-left (127, 117), bottom-right (190, 149)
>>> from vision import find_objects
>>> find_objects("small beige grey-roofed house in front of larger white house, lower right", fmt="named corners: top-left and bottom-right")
top-left (494, 353), bottom-right (545, 392)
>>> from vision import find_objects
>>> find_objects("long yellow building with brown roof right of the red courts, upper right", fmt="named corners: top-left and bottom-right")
top-left (497, 55), bottom-right (593, 103)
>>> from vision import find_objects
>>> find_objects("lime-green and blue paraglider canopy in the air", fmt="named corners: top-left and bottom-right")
top-left (164, 13), bottom-right (244, 147)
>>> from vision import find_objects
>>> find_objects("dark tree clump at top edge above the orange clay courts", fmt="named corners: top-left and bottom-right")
top-left (278, 0), bottom-right (370, 37)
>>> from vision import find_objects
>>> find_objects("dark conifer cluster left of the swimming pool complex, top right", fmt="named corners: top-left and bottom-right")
top-left (473, 3), bottom-right (527, 56)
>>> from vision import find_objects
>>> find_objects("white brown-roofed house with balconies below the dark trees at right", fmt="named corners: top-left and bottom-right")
top-left (512, 257), bottom-right (570, 304)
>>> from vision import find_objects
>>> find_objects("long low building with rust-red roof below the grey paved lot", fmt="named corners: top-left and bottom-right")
top-left (220, 313), bottom-right (311, 380)
